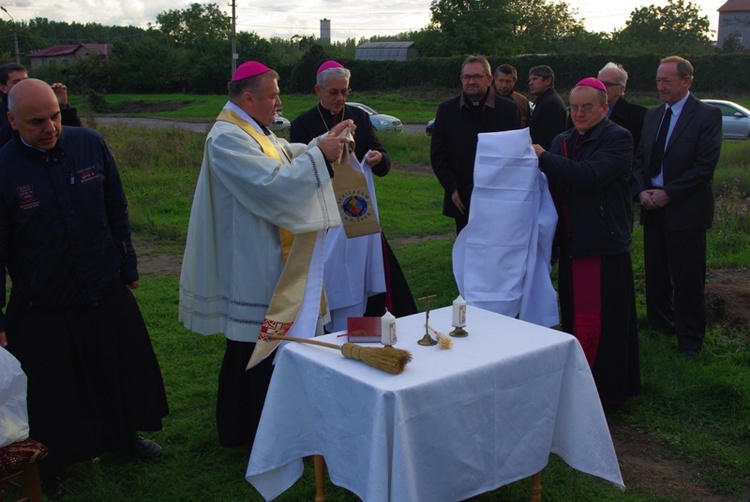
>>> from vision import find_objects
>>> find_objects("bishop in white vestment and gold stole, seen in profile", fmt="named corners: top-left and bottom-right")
top-left (179, 61), bottom-right (352, 447)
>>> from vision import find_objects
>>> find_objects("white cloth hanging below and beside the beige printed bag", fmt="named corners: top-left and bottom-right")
top-left (323, 152), bottom-right (385, 331)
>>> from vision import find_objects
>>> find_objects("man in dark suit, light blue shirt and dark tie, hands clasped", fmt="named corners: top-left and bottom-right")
top-left (632, 56), bottom-right (722, 359)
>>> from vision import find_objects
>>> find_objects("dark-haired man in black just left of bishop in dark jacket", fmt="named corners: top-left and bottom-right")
top-left (529, 65), bottom-right (568, 150)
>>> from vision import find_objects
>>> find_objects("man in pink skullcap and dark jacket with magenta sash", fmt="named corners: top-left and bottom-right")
top-left (534, 77), bottom-right (641, 405)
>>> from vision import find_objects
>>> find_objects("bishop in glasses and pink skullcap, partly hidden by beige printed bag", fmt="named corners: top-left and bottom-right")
top-left (289, 61), bottom-right (417, 331)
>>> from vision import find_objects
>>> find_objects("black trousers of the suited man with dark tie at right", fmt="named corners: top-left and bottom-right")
top-left (643, 209), bottom-right (706, 352)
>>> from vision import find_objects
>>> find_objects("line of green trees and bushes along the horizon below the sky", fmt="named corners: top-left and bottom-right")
top-left (0, 0), bottom-right (741, 102)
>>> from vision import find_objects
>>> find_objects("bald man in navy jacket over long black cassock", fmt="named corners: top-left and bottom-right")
top-left (0, 79), bottom-right (168, 499)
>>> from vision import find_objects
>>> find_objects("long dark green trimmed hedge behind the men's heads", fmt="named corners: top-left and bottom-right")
top-left (279, 54), bottom-right (750, 93)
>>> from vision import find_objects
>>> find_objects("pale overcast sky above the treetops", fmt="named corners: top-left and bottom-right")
top-left (0, 0), bottom-right (726, 43)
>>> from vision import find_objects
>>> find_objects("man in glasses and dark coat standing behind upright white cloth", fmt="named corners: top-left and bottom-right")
top-left (430, 56), bottom-right (521, 234)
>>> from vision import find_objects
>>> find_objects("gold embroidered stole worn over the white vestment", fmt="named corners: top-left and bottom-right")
top-left (216, 108), bottom-right (318, 369)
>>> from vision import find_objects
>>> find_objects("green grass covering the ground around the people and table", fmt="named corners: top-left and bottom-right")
top-left (7, 104), bottom-right (750, 502)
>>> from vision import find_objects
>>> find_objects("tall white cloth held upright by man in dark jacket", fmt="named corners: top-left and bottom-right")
top-left (453, 128), bottom-right (559, 327)
